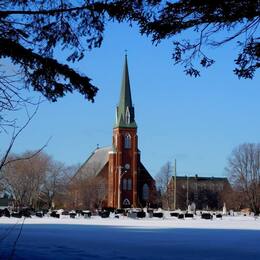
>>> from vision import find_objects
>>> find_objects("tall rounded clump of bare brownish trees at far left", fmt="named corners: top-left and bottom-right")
top-left (0, 151), bottom-right (72, 208)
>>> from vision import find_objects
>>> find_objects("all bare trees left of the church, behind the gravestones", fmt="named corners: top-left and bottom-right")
top-left (0, 151), bottom-right (104, 209)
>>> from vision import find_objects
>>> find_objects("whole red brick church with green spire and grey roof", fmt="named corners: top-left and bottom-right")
top-left (76, 56), bottom-right (156, 208)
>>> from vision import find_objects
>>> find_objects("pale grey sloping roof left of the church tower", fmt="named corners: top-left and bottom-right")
top-left (76, 146), bottom-right (112, 177)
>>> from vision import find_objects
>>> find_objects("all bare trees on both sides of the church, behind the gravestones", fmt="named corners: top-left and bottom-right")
top-left (0, 143), bottom-right (260, 214)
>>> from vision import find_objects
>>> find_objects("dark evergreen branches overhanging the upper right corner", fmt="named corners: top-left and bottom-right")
top-left (135, 0), bottom-right (260, 78)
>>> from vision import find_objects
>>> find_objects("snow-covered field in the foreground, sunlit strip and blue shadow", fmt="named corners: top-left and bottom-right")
top-left (0, 216), bottom-right (260, 260)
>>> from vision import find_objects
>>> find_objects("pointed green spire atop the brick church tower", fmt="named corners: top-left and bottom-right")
top-left (115, 55), bottom-right (137, 128)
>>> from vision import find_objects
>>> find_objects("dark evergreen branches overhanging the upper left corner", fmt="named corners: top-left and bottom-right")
top-left (0, 0), bottom-right (103, 101)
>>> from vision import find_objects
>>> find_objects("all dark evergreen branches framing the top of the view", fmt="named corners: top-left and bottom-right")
top-left (0, 0), bottom-right (260, 101)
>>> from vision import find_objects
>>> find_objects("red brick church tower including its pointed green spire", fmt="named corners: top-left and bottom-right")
top-left (108, 55), bottom-right (139, 208)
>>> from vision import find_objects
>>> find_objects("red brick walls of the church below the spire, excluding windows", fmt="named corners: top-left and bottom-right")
top-left (104, 128), bottom-right (156, 208)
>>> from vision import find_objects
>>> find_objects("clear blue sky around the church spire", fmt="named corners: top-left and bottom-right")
top-left (1, 24), bottom-right (260, 176)
